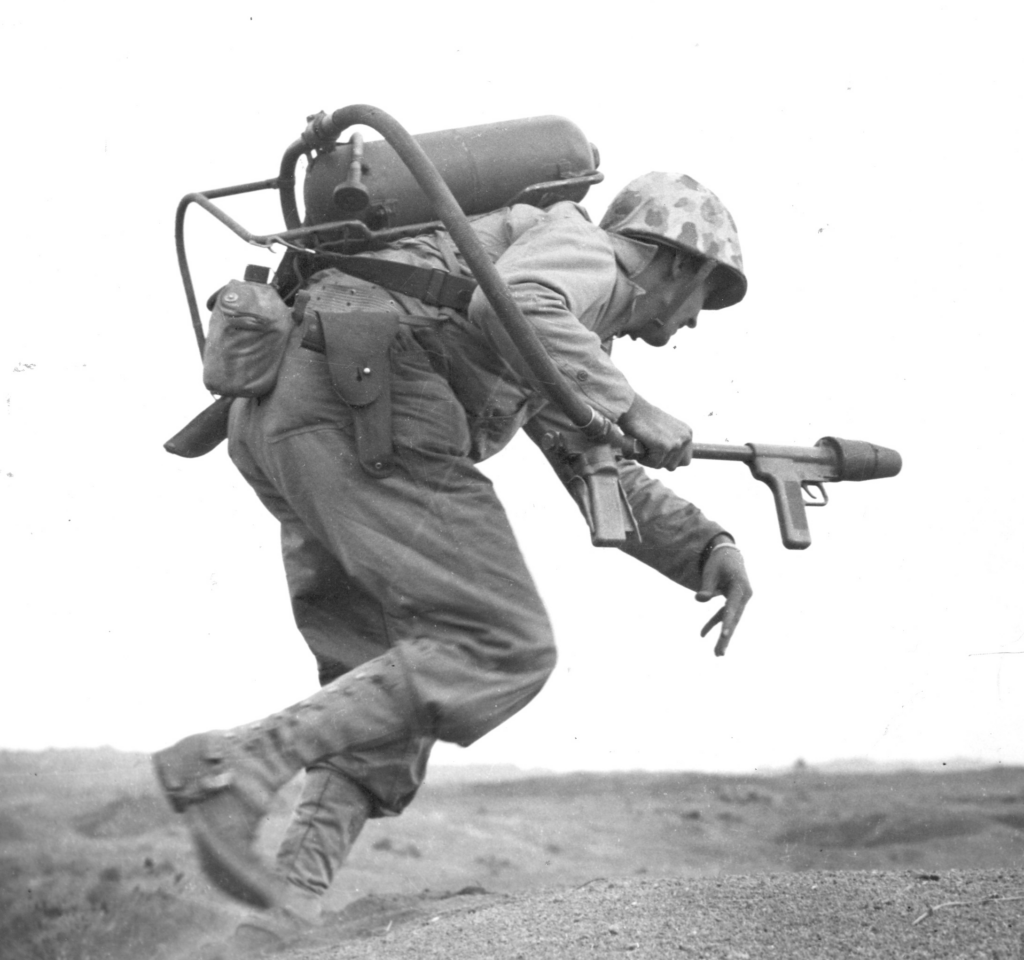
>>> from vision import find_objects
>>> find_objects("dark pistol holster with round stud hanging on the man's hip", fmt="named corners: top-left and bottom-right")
top-left (294, 277), bottom-right (401, 479)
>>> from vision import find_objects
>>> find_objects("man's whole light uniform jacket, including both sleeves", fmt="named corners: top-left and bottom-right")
top-left (360, 202), bottom-right (724, 590)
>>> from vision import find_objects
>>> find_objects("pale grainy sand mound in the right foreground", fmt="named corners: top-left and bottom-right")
top-left (274, 871), bottom-right (1024, 960)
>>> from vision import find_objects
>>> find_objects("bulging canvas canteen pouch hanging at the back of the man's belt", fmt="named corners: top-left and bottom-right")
top-left (203, 280), bottom-right (294, 397)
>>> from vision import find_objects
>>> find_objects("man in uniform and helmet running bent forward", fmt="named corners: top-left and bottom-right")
top-left (155, 173), bottom-right (751, 951)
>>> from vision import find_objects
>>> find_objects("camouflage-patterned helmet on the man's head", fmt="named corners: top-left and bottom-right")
top-left (601, 173), bottom-right (746, 310)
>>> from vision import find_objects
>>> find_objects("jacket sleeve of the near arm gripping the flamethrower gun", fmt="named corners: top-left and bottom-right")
top-left (469, 203), bottom-right (635, 421)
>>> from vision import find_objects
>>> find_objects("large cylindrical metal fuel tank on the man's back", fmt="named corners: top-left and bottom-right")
top-left (303, 117), bottom-right (600, 229)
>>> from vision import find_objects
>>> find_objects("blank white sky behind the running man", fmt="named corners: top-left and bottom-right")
top-left (0, 0), bottom-right (1024, 771)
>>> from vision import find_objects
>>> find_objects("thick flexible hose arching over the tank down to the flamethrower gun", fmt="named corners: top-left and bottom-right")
top-left (279, 103), bottom-right (621, 442)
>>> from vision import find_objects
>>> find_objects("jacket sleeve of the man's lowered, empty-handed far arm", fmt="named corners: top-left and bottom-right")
top-left (524, 406), bottom-right (728, 592)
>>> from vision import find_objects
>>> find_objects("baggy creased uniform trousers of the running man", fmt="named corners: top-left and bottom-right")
top-left (228, 294), bottom-right (555, 816)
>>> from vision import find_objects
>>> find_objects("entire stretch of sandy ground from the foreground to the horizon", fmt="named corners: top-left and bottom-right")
top-left (0, 751), bottom-right (1024, 960)
